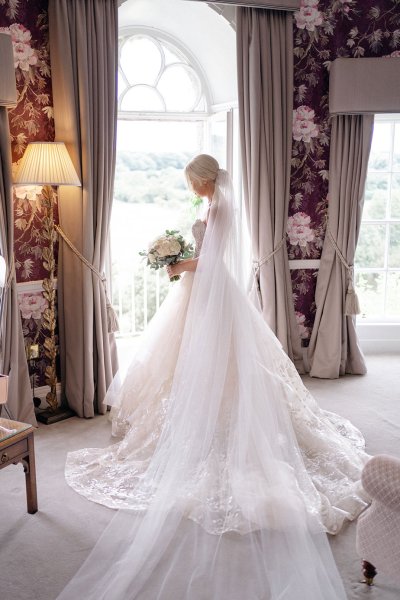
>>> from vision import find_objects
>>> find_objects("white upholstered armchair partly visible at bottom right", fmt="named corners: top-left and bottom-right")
top-left (356, 454), bottom-right (400, 585)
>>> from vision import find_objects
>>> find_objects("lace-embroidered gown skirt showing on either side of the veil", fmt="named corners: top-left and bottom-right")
top-left (66, 273), bottom-right (369, 534)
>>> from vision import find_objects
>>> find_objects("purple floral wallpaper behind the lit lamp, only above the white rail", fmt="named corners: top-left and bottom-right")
top-left (0, 0), bottom-right (54, 282)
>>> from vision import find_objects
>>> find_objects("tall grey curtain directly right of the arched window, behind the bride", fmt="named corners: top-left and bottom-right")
top-left (237, 8), bottom-right (303, 371)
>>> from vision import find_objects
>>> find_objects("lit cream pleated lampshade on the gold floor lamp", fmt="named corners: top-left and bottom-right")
top-left (14, 142), bottom-right (81, 185)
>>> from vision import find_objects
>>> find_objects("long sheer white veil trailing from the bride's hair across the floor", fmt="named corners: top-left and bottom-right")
top-left (59, 170), bottom-right (346, 600)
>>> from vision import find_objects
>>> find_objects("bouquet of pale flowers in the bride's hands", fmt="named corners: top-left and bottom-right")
top-left (139, 229), bottom-right (193, 281)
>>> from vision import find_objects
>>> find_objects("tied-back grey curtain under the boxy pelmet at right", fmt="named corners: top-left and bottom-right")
top-left (309, 115), bottom-right (373, 379)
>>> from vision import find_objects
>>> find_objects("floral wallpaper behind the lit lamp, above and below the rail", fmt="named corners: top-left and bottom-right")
top-left (0, 0), bottom-right (58, 386)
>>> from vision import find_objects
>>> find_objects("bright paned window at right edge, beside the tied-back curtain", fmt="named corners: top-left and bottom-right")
top-left (355, 115), bottom-right (400, 321)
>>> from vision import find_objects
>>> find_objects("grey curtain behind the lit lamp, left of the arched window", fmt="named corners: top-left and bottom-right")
top-left (49, 0), bottom-right (118, 417)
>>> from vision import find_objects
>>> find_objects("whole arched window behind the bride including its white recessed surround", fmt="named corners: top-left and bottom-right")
top-left (110, 9), bottom-right (238, 352)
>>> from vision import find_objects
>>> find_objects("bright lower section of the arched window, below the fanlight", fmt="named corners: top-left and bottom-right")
top-left (111, 120), bottom-right (204, 335)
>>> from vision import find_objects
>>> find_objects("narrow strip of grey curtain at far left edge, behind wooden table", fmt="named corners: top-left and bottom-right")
top-left (0, 106), bottom-right (37, 425)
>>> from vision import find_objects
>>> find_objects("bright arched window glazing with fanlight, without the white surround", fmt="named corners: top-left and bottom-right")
top-left (111, 30), bottom-right (208, 337)
